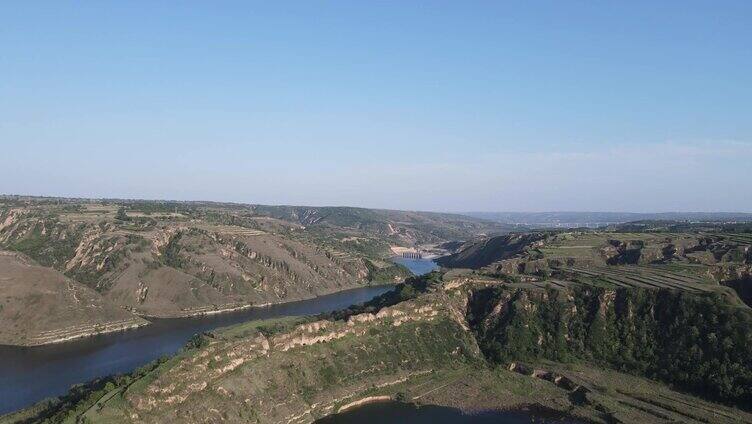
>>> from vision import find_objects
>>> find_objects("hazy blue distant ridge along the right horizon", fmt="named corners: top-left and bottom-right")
top-left (463, 212), bottom-right (752, 227)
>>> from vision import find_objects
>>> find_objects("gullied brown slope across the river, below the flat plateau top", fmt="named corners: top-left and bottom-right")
top-left (0, 207), bottom-right (407, 317)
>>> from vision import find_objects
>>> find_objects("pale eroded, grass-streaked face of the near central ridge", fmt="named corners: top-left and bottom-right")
top-left (112, 293), bottom-right (481, 422)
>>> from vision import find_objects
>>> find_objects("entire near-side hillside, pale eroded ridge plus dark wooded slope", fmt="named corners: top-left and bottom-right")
top-left (7, 274), bottom-right (752, 423)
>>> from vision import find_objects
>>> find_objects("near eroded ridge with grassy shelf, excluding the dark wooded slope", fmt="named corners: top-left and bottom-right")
top-left (5, 287), bottom-right (752, 424)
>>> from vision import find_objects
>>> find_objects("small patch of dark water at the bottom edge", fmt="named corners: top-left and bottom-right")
top-left (315, 402), bottom-right (579, 424)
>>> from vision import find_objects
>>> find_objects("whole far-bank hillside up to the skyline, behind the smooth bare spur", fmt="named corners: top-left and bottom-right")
top-left (0, 197), bottom-right (500, 342)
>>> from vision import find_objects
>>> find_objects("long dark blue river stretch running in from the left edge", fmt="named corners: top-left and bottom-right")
top-left (0, 286), bottom-right (392, 414)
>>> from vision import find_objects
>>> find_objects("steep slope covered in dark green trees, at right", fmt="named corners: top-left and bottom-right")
top-left (470, 287), bottom-right (752, 406)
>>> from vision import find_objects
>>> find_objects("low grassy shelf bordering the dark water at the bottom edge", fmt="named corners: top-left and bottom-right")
top-left (314, 362), bottom-right (752, 424)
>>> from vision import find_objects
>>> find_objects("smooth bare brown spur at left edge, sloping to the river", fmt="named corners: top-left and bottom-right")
top-left (0, 251), bottom-right (147, 346)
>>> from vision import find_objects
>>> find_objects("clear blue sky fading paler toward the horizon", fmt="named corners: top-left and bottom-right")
top-left (0, 0), bottom-right (752, 212)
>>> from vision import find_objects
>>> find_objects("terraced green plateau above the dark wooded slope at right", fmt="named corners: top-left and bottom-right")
top-left (438, 224), bottom-right (752, 305)
